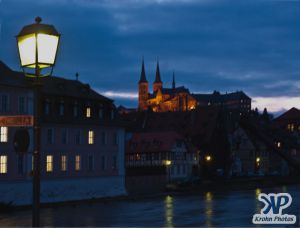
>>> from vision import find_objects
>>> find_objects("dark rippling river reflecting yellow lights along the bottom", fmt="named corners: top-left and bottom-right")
top-left (0, 186), bottom-right (300, 227)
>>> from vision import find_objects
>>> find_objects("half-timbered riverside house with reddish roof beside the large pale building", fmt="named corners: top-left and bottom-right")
top-left (125, 131), bottom-right (198, 182)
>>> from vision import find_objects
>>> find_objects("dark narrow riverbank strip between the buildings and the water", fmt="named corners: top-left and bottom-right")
top-left (0, 177), bottom-right (300, 213)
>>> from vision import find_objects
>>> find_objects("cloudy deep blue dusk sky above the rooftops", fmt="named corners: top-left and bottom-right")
top-left (0, 0), bottom-right (300, 112)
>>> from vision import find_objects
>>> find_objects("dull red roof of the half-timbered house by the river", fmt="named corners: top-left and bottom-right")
top-left (126, 131), bottom-right (184, 153)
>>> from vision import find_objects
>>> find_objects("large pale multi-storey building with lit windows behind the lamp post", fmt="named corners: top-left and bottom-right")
top-left (0, 61), bottom-right (126, 204)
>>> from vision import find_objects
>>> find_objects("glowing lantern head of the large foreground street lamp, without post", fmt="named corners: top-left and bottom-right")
top-left (17, 17), bottom-right (60, 74)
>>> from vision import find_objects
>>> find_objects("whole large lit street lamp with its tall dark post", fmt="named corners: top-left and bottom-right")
top-left (16, 17), bottom-right (60, 227)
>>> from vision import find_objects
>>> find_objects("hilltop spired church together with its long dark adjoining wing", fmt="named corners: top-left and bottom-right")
top-left (138, 61), bottom-right (251, 113)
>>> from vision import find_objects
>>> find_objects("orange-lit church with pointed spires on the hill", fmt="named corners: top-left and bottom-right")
top-left (139, 60), bottom-right (197, 112)
